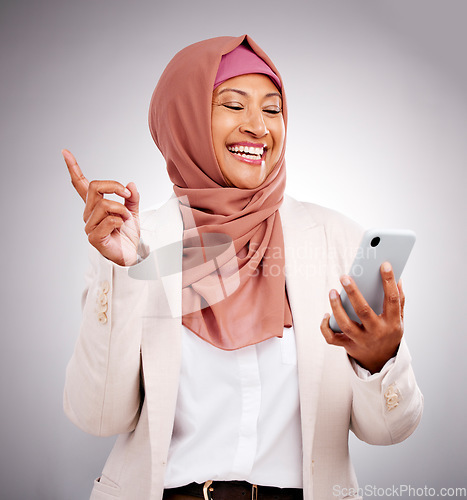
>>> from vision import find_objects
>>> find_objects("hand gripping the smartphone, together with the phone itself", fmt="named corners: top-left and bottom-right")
top-left (321, 230), bottom-right (415, 373)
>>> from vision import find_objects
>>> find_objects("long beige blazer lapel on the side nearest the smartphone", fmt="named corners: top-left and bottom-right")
top-left (280, 197), bottom-right (327, 491)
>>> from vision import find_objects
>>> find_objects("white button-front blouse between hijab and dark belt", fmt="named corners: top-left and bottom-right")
top-left (165, 327), bottom-right (302, 488)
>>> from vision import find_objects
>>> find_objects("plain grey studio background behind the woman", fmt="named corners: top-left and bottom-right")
top-left (0, 0), bottom-right (467, 500)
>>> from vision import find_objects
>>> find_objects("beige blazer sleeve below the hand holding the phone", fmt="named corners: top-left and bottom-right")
top-left (349, 338), bottom-right (423, 445)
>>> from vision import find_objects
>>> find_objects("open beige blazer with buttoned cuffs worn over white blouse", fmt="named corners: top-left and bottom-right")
top-left (64, 197), bottom-right (423, 500)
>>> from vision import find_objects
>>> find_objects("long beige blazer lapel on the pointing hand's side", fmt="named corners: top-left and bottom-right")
top-left (131, 197), bottom-right (183, 499)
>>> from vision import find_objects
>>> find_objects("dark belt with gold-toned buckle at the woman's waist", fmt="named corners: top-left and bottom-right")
top-left (163, 481), bottom-right (303, 500)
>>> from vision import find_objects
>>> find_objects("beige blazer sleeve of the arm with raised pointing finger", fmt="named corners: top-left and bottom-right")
top-left (64, 247), bottom-right (145, 436)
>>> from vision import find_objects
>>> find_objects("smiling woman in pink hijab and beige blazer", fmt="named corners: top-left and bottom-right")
top-left (64, 36), bottom-right (422, 500)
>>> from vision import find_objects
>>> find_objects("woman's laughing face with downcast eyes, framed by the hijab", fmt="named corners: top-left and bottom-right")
top-left (211, 74), bottom-right (285, 189)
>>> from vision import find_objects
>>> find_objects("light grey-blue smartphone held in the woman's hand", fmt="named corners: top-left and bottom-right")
top-left (329, 229), bottom-right (415, 332)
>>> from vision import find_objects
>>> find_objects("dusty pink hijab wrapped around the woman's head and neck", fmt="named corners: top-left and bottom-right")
top-left (149, 35), bottom-right (292, 350)
